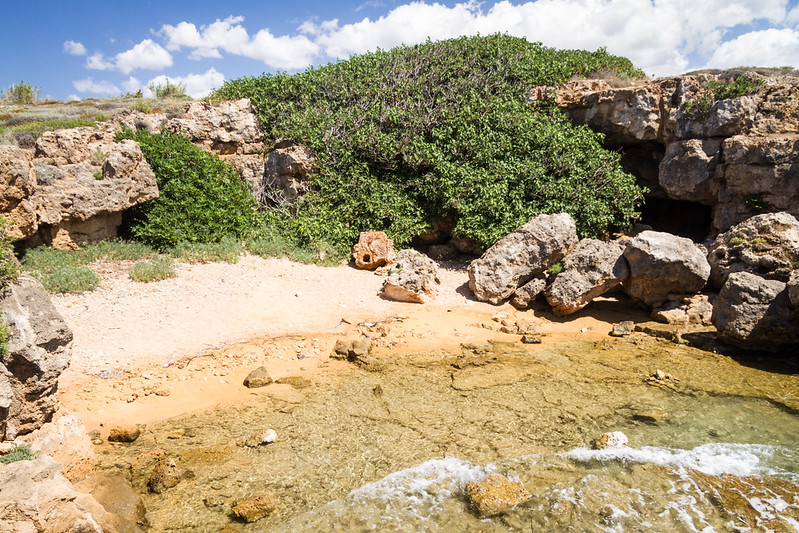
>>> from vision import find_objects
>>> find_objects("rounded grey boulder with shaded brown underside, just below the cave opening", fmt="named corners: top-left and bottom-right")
top-left (624, 231), bottom-right (710, 306)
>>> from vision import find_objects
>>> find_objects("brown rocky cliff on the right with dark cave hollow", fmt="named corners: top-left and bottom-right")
top-left (552, 71), bottom-right (799, 238)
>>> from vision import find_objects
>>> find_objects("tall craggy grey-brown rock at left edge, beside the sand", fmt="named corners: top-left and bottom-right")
top-left (0, 275), bottom-right (72, 440)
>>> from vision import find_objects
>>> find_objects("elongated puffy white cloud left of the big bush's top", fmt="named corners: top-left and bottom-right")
top-left (158, 16), bottom-right (319, 69)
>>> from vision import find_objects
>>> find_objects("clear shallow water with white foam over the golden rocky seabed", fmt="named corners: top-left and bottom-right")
top-left (95, 337), bottom-right (799, 531)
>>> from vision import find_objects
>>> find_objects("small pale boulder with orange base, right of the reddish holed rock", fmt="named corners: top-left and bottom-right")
top-left (381, 249), bottom-right (441, 304)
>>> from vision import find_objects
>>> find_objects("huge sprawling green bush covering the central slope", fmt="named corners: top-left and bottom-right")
top-left (214, 35), bottom-right (642, 250)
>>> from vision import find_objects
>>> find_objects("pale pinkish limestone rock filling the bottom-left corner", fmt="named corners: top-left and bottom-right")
top-left (0, 455), bottom-right (122, 533)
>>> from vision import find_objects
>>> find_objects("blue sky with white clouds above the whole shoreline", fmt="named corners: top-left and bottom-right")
top-left (0, 0), bottom-right (799, 100)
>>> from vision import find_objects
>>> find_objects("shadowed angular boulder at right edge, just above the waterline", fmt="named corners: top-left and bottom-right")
top-left (713, 272), bottom-right (799, 353)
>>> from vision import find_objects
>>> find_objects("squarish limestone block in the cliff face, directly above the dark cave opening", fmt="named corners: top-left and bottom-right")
top-left (658, 138), bottom-right (721, 205)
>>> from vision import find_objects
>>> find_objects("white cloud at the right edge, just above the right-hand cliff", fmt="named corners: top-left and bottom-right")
top-left (707, 28), bottom-right (799, 68)
